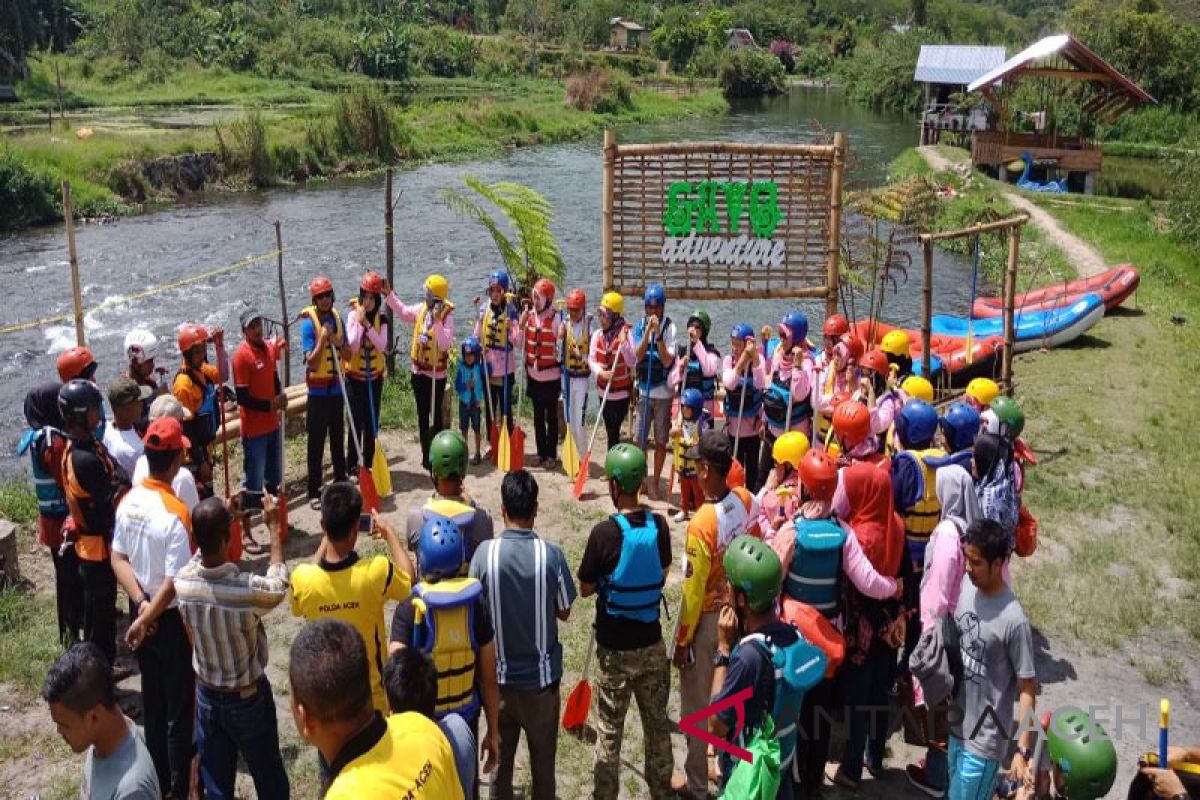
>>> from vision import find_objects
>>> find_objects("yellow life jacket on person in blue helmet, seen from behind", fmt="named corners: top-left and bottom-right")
top-left (413, 578), bottom-right (484, 718)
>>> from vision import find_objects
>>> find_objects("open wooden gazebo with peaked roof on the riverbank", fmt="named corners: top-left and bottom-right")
top-left (967, 34), bottom-right (1154, 193)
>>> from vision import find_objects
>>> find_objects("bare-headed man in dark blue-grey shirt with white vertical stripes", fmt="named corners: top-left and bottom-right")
top-left (468, 469), bottom-right (575, 800)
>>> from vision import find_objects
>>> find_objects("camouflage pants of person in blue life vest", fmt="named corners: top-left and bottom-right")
top-left (592, 642), bottom-right (674, 800)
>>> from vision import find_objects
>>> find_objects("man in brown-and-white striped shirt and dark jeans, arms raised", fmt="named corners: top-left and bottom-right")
top-left (175, 495), bottom-right (288, 800)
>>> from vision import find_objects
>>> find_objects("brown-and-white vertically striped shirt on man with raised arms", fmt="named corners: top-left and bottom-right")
top-left (175, 553), bottom-right (288, 690)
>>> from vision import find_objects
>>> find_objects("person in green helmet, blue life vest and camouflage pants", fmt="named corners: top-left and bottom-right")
top-left (577, 443), bottom-right (673, 800)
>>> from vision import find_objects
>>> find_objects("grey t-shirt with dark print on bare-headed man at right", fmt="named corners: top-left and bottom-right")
top-left (952, 578), bottom-right (1037, 762)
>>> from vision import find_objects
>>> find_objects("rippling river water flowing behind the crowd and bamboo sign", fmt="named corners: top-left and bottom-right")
top-left (0, 88), bottom-right (971, 473)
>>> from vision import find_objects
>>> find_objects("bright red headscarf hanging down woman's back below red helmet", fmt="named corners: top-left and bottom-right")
top-left (838, 462), bottom-right (905, 578)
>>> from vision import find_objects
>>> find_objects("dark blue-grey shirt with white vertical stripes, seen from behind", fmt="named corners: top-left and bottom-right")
top-left (469, 529), bottom-right (575, 691)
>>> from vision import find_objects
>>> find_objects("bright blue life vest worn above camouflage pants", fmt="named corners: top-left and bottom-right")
top-left (599, 512), bottom-right (664, 622)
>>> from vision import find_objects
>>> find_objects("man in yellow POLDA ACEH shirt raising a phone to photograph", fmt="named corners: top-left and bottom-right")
top-left (292, 481), bottom-right (413, 714)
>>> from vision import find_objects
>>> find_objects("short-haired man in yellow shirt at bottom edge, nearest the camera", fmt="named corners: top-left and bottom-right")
top-left (288, 618), bottom-right (463, 800)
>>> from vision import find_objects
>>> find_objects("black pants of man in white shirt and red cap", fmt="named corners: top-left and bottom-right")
top-left (130, 608), bottom-right (196, 798)
